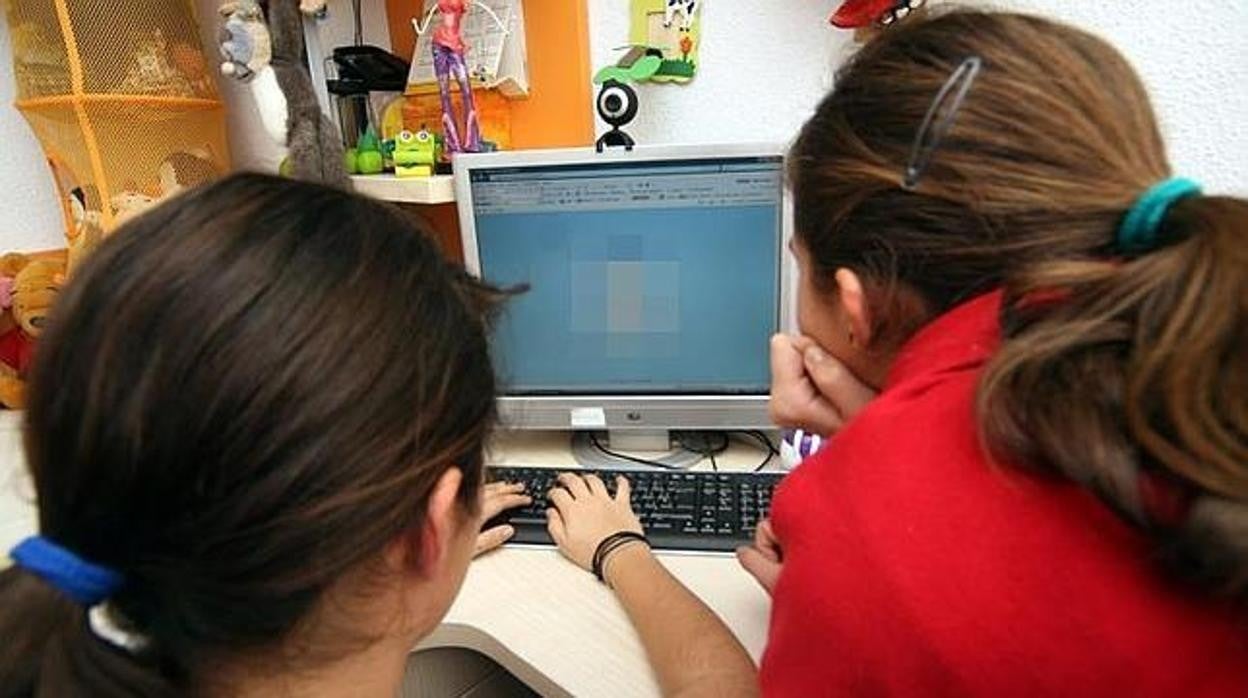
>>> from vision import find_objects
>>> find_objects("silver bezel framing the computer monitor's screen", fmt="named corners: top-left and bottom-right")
top-left (454, 144), bottom-right (797, 431)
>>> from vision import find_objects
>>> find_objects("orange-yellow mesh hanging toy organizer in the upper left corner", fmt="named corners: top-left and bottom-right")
top-left (4, 0), bottom-right (230, 237)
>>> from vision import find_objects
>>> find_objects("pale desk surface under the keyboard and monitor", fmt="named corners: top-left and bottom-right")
top-left (0, 412), bottom-right (769, 698)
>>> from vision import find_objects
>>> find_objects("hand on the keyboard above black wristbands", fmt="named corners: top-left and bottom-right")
top-left (547, 472), bottom-right (643, 569)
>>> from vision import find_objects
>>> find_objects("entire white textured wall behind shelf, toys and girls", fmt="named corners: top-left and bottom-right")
top-left (0, 0), bottom-right (1248, 251)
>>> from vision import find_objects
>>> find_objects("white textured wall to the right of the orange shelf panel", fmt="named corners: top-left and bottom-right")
top-left (589, 0), bottom-right (1248, 195)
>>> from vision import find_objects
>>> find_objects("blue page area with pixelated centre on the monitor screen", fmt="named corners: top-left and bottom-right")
top-left (477, 205), bottom-right (780, 395)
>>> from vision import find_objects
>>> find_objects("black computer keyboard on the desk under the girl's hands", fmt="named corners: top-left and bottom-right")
top-left (487, 467), bottom-right (784, 552)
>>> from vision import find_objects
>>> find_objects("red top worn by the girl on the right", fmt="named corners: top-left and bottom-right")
top-left (761, 293), bottom-right (1248, 698)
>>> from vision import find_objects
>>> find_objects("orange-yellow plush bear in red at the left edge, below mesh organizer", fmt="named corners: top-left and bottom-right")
top-left (0, 255), bottom-right (65, 410)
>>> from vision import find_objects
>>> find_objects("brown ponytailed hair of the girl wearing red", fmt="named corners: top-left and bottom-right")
top-left (790, 10), bottom-right (1248, 598)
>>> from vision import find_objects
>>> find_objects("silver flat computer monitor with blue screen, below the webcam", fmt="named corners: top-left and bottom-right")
top-left (456, 145), bottom-right (791, 444)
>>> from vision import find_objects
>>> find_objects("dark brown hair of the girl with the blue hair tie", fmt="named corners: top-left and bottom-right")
top-left (0, 175), bottom-right (506, 696)
